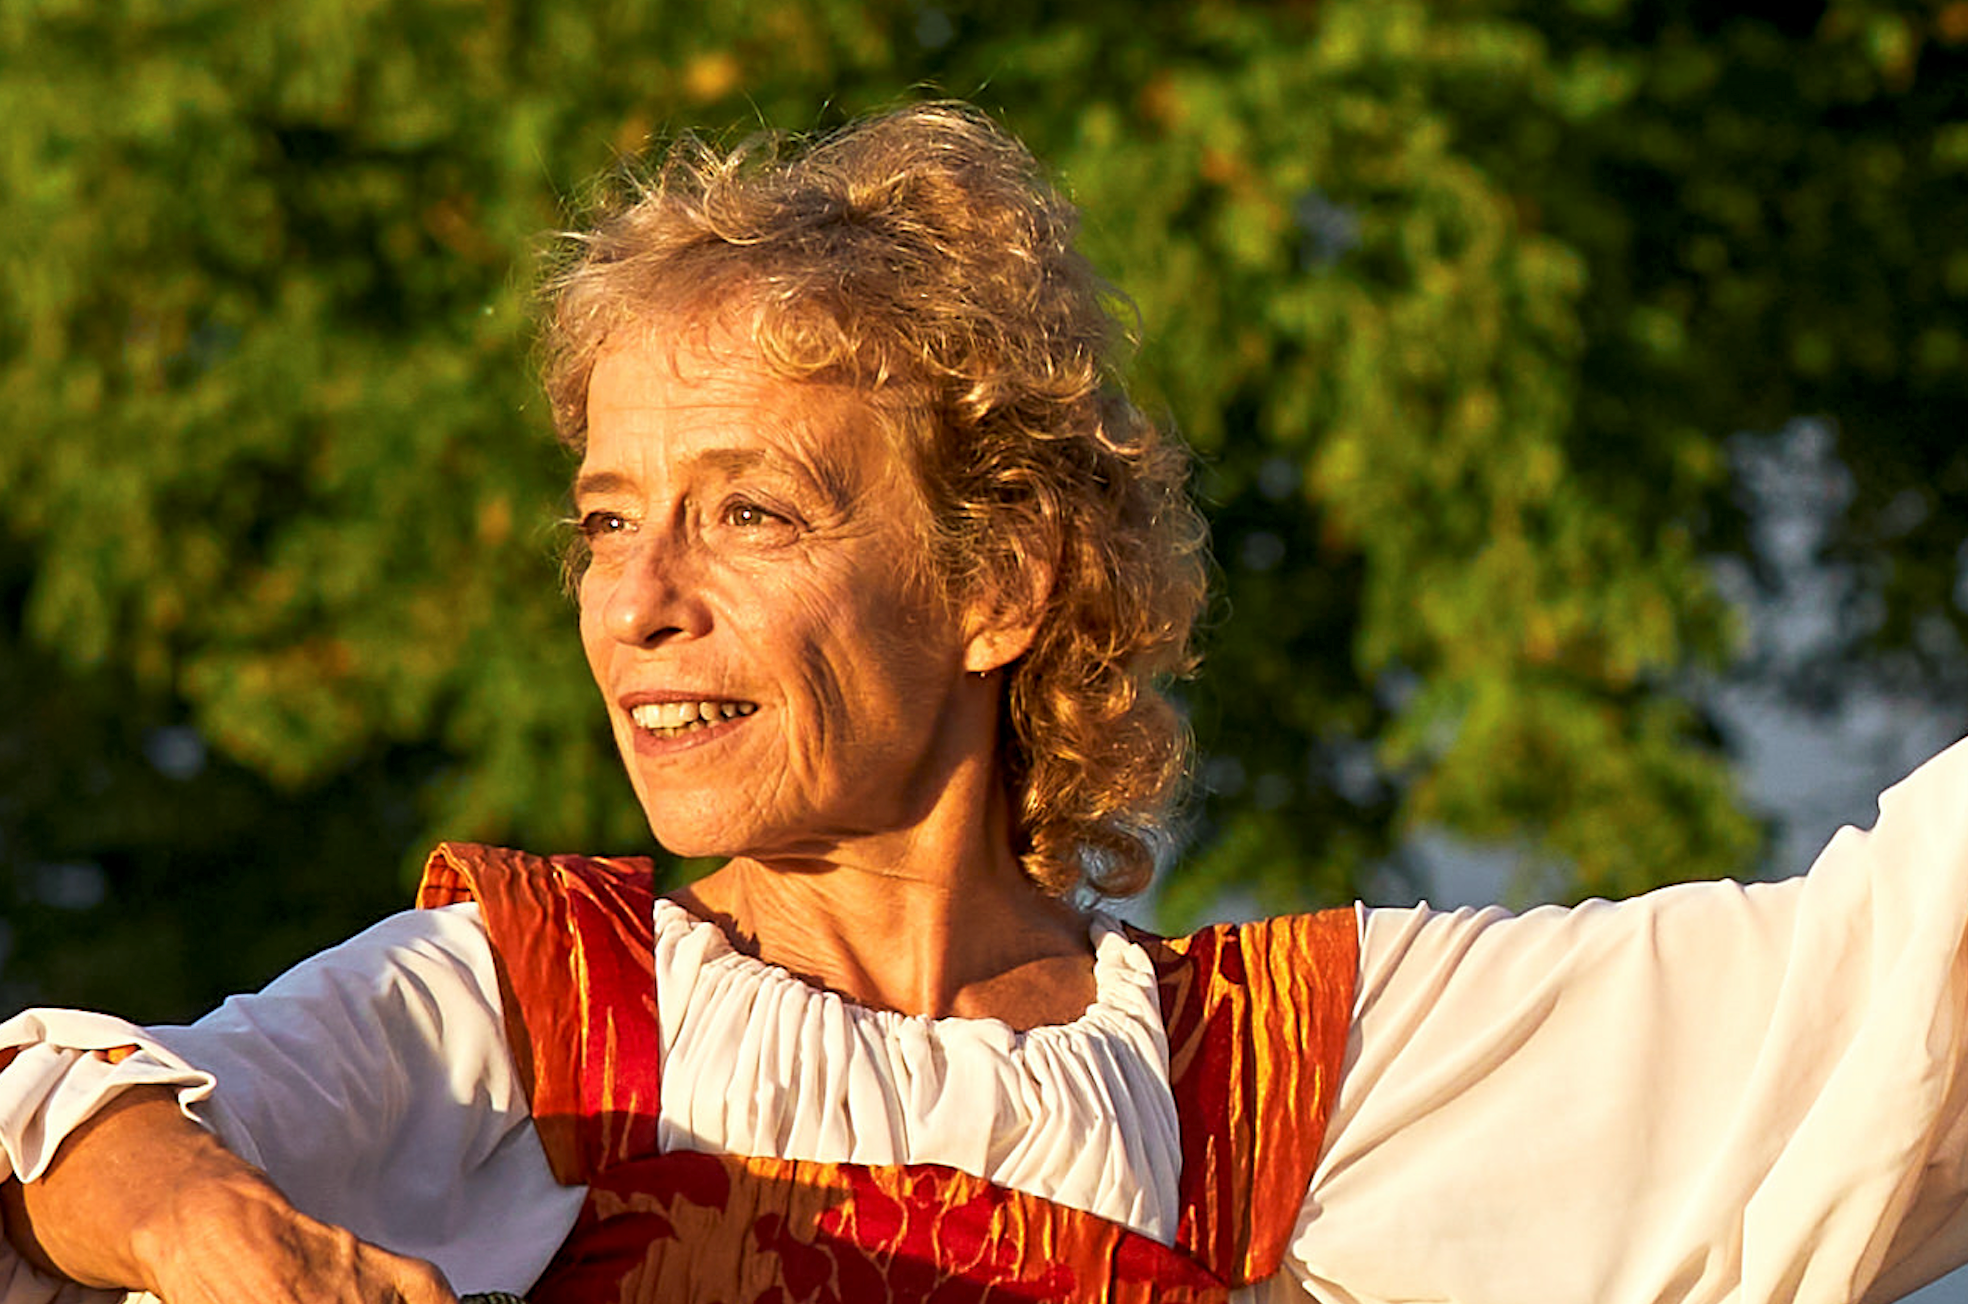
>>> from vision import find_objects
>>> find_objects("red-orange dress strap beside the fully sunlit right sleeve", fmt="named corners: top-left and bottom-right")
top-left (1138, 909), bottom-right (1360, 1282)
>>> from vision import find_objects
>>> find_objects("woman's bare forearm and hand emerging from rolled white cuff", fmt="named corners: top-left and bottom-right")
top-left (0, 1086), bottom-right (455, 1304)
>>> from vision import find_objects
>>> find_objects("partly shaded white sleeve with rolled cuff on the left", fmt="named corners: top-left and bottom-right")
top-left (0, 905), bottom-right (583, 1304)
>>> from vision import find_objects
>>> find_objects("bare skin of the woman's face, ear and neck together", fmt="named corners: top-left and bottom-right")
top-left (575, 317), bottom-right (1092, 1029)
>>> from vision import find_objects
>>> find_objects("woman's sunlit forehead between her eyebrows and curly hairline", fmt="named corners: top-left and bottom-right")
top-left (583, 328), bottom-right (895, 486)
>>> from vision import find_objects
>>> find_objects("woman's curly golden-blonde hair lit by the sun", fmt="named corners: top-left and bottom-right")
top-left (545, 104), bottom-right (1206, 897)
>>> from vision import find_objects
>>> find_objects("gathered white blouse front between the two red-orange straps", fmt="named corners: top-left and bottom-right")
top-left (655, 899), bottom-right (1181, 1243)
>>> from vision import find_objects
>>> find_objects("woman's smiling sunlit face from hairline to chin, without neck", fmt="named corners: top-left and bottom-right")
top-left (575, 330), bottom-right (996, 858)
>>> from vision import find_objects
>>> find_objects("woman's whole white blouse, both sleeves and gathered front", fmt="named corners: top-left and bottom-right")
top-left (11, 745), bottom-right (1968, 1304)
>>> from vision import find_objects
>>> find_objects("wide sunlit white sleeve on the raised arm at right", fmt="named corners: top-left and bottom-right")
top-left (1287, 743), bottom-right (1968, 1304)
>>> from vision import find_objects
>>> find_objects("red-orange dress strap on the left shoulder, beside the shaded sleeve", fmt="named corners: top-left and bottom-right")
top-left (417, 842), bottom-right (661, 1186)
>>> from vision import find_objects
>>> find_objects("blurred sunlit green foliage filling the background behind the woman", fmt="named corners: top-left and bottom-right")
top-left (0, 0), bottom-right (1968, 1013)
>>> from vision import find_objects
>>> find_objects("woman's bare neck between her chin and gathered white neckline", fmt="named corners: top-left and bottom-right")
top-left (675, 767), bottom-right (1094, 1029)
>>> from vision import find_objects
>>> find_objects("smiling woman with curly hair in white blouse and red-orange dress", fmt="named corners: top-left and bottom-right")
top-left (0, 106), bottom-right (1968, 1304)
